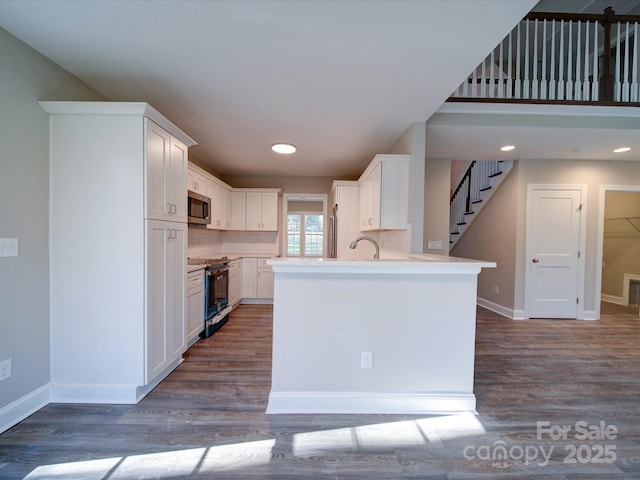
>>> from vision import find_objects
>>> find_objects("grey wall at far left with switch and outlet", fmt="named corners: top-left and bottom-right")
top-left (0, 29), bottom-right (105, 422)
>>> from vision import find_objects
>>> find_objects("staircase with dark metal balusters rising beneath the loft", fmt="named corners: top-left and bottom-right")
top-left (449, 160), bottom-right (513, 251)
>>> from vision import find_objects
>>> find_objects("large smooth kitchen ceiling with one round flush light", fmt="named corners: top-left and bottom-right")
top-left (0, 0), bottom-right (536, 178)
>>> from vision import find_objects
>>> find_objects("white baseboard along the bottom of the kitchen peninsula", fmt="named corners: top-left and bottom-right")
top-left (266, 391), bottom-right (476, 415)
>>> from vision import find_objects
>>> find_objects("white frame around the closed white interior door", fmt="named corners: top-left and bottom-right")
top-left (523, 183), bottom-right (597, 320)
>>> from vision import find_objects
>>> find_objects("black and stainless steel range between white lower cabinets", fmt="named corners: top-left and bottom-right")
top-left (187, 257), bottom-right (229, 338)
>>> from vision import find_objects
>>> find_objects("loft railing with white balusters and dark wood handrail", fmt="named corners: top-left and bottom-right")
top-left (452, 7), bottom-right (640, 103)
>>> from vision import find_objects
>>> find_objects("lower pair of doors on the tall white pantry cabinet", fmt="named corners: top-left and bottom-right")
top-left (145, 220), bottom-right (187, 383)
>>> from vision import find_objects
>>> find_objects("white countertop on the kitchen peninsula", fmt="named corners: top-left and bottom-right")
top-left (267, 254), bottom-right (496, 274)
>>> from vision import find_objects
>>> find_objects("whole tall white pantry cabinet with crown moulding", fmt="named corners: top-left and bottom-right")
top-left (40, 102), bottom-right (195, 403)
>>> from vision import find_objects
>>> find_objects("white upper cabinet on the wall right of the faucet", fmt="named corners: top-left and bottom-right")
top-left (358, 155), bottom-right (411, 231)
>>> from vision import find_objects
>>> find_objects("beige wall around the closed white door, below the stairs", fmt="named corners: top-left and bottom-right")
top-left (452, 160), bottom-right (640, 313)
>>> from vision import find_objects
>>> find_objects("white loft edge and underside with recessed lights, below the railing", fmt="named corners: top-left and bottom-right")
top-left (427, 103), bottom-right (640, 161)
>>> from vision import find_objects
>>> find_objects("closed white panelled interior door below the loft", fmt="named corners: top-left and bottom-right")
top-left (527, 187), bottom-right (582, 318)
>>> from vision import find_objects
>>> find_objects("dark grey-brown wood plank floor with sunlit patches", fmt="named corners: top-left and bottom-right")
top-left (0, 303), bottom-right (640, 480)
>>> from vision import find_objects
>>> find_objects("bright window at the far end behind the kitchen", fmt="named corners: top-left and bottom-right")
top-left (287, 212), bottom-right (324, 257)
